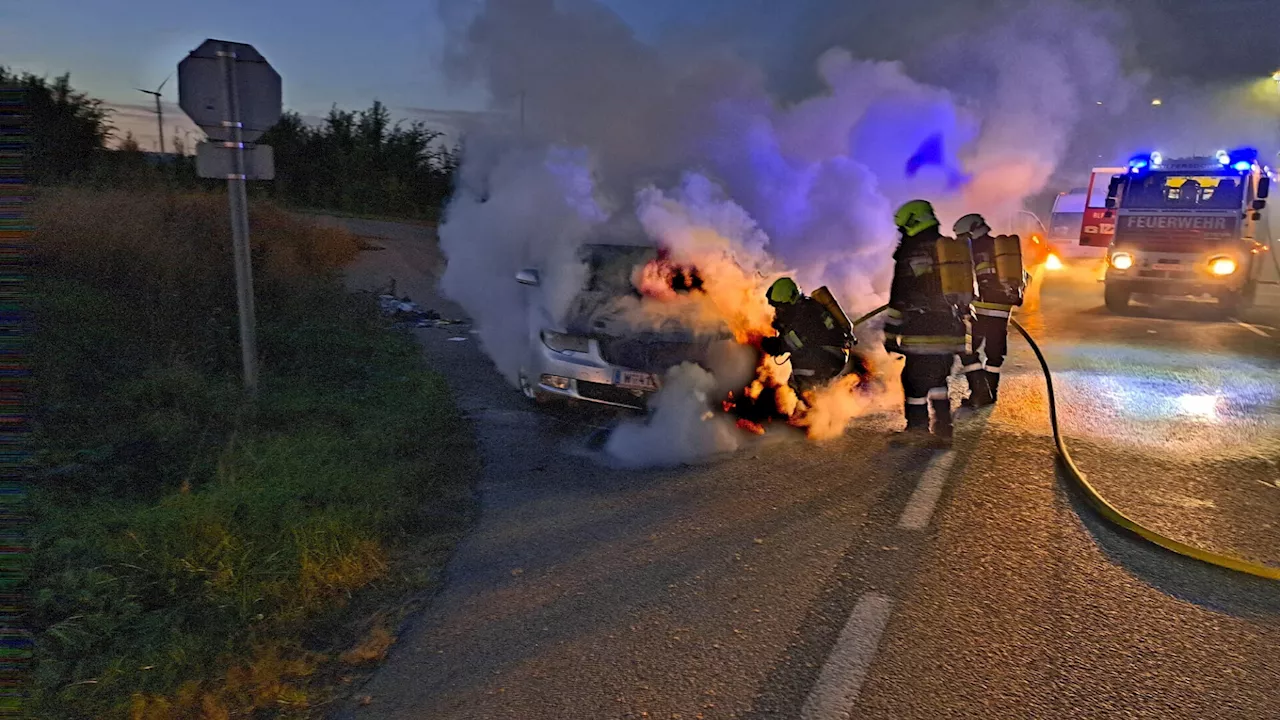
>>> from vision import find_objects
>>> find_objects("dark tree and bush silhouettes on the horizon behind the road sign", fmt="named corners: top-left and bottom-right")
top-left (0, 67), bottom-right (458, 219)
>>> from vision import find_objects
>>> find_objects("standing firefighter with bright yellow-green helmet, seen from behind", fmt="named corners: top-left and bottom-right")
top-left (884, 200), bottom-right (973, 443)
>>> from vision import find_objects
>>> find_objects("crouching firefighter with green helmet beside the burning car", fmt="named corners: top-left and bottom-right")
top-left (760, 278), bottom-right (858, 393)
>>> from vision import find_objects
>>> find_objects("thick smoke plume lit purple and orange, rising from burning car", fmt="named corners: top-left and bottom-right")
top-left (440, 0), bottom-right (1187, 457)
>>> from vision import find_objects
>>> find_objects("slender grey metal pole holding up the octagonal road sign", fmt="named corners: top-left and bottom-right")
top-left (218, 44), bottom-right (257, 396)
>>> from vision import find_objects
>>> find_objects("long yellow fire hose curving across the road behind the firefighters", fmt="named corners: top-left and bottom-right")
top-left (854, 299), bottom-right (1280, 580)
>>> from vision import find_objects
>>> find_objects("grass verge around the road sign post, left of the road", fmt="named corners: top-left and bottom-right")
top-left (32, 190), bottom-right (477, 719)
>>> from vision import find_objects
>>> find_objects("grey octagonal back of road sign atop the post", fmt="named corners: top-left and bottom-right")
top-left (178, 40), bottom-right (282, 142)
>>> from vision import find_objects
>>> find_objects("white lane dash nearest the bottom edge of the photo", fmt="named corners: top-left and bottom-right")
top-left (800, 592), bottom-right (893, 720)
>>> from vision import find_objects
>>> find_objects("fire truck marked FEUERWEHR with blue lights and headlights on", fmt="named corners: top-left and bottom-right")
top-left (1080, 149), bottom-right (1274, 313)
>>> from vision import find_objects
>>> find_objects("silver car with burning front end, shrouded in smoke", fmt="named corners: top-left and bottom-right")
top-left (516, 242), bottom-right (736, 410)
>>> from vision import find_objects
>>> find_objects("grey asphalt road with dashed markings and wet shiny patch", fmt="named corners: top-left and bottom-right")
top-left (339, 220), bottom-right (1280, 720)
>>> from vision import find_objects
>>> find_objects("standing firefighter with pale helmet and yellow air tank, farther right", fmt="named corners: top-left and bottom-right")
top-left (952, 213), bottom-right (1027, 409)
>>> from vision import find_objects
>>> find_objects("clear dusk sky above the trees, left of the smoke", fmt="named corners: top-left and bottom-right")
top-left (0, 0), bottom-right (719, 149)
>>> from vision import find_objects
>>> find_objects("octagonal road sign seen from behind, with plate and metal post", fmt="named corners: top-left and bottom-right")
top-left (178, 40), bottom-right (283, 397)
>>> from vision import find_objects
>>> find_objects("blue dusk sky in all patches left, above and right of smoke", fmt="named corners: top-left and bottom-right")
top-left (0, 0), bottom-right (1280, 147)
